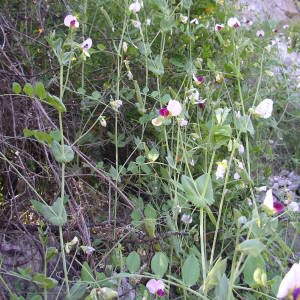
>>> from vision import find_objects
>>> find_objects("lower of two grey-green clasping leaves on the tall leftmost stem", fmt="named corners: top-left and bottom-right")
top-left (31, 198), bottom-right (67, 226)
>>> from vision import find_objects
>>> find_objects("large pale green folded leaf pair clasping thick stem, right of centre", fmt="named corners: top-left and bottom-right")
top-left (181, 174), bottom-right (214, 207)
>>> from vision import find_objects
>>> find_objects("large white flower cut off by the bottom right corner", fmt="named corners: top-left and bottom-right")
top-left (277, 263), bottom-right (300, 300)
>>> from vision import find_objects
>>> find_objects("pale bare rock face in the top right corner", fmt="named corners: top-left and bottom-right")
top-left (238, 0), bottom-right (300, 22)
